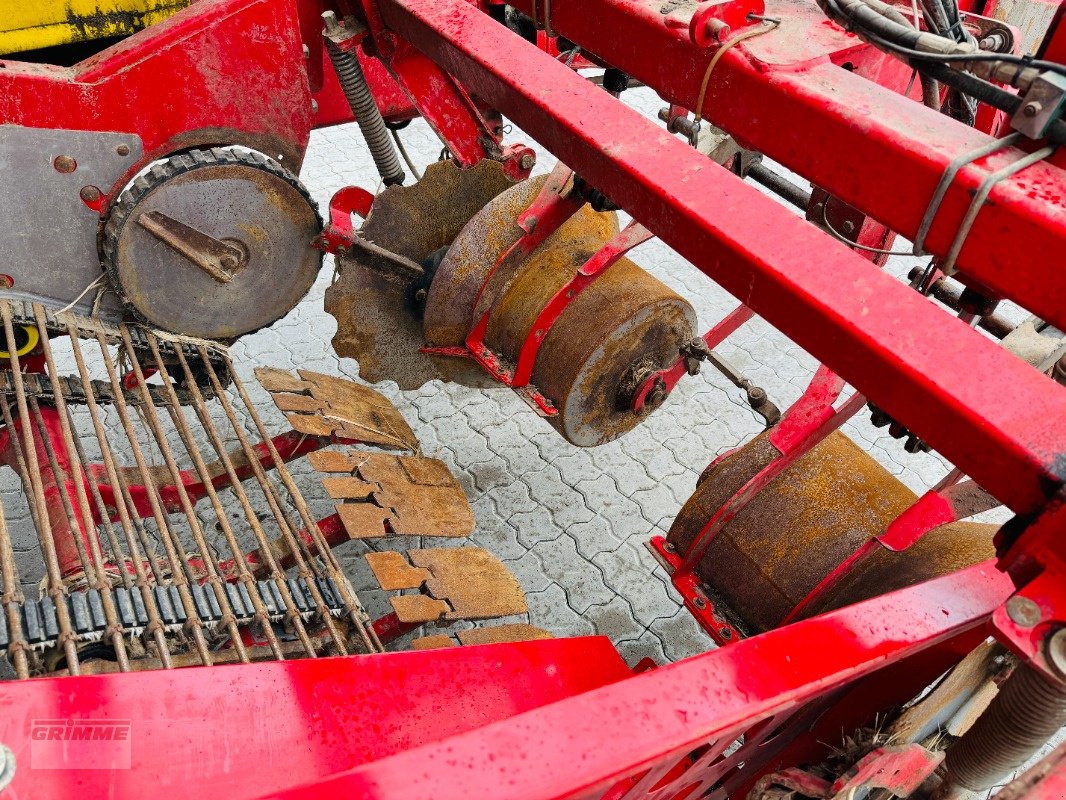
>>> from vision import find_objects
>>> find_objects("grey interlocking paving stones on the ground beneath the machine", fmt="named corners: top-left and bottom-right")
top-left (0, 90), bottom-right (1057, 785)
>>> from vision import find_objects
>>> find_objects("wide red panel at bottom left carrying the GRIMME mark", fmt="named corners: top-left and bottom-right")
top-left (0, 637), bottom-right (631, 800)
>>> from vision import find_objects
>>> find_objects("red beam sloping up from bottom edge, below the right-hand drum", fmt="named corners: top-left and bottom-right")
top-left (270, 562), bottom-right (1012, 800)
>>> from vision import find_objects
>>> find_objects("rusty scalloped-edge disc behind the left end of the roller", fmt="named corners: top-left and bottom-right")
top-left (325, 160), bottom-right (511, 389)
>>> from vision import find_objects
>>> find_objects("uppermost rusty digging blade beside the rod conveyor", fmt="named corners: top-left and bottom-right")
top-left (256, 368), bottom-right (418, 451)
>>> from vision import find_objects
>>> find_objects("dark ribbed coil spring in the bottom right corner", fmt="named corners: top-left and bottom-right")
top-left (939, 666), bottom-right (1066, 797)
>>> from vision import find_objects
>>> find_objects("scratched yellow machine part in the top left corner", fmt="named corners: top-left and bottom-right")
top-left (0, 0), bottom-right (190, 55)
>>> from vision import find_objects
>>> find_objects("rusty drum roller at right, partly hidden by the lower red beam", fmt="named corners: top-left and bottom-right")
top-left (667, 431), bottom-right (997, 634)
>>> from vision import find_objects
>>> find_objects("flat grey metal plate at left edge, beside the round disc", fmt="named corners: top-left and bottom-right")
top-left (0, 125), bottom-right (142, 320)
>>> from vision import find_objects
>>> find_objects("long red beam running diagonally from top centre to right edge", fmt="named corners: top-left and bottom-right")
top-left (378, 0), bottom-right (1066, 512)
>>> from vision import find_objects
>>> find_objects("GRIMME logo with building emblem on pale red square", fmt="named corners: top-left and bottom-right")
top-left (30, 719), bottom-right (132, 769)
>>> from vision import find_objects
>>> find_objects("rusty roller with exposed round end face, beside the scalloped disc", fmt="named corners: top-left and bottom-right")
top-left (424, 176), bottom-right (696, 447)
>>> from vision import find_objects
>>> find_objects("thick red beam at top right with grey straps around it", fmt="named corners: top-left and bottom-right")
top-left (505, 0), bottom-right (1066, 332)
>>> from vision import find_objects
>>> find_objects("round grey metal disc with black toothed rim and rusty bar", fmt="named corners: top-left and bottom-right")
top-left (103, 149), bottom-right (322, 339)
